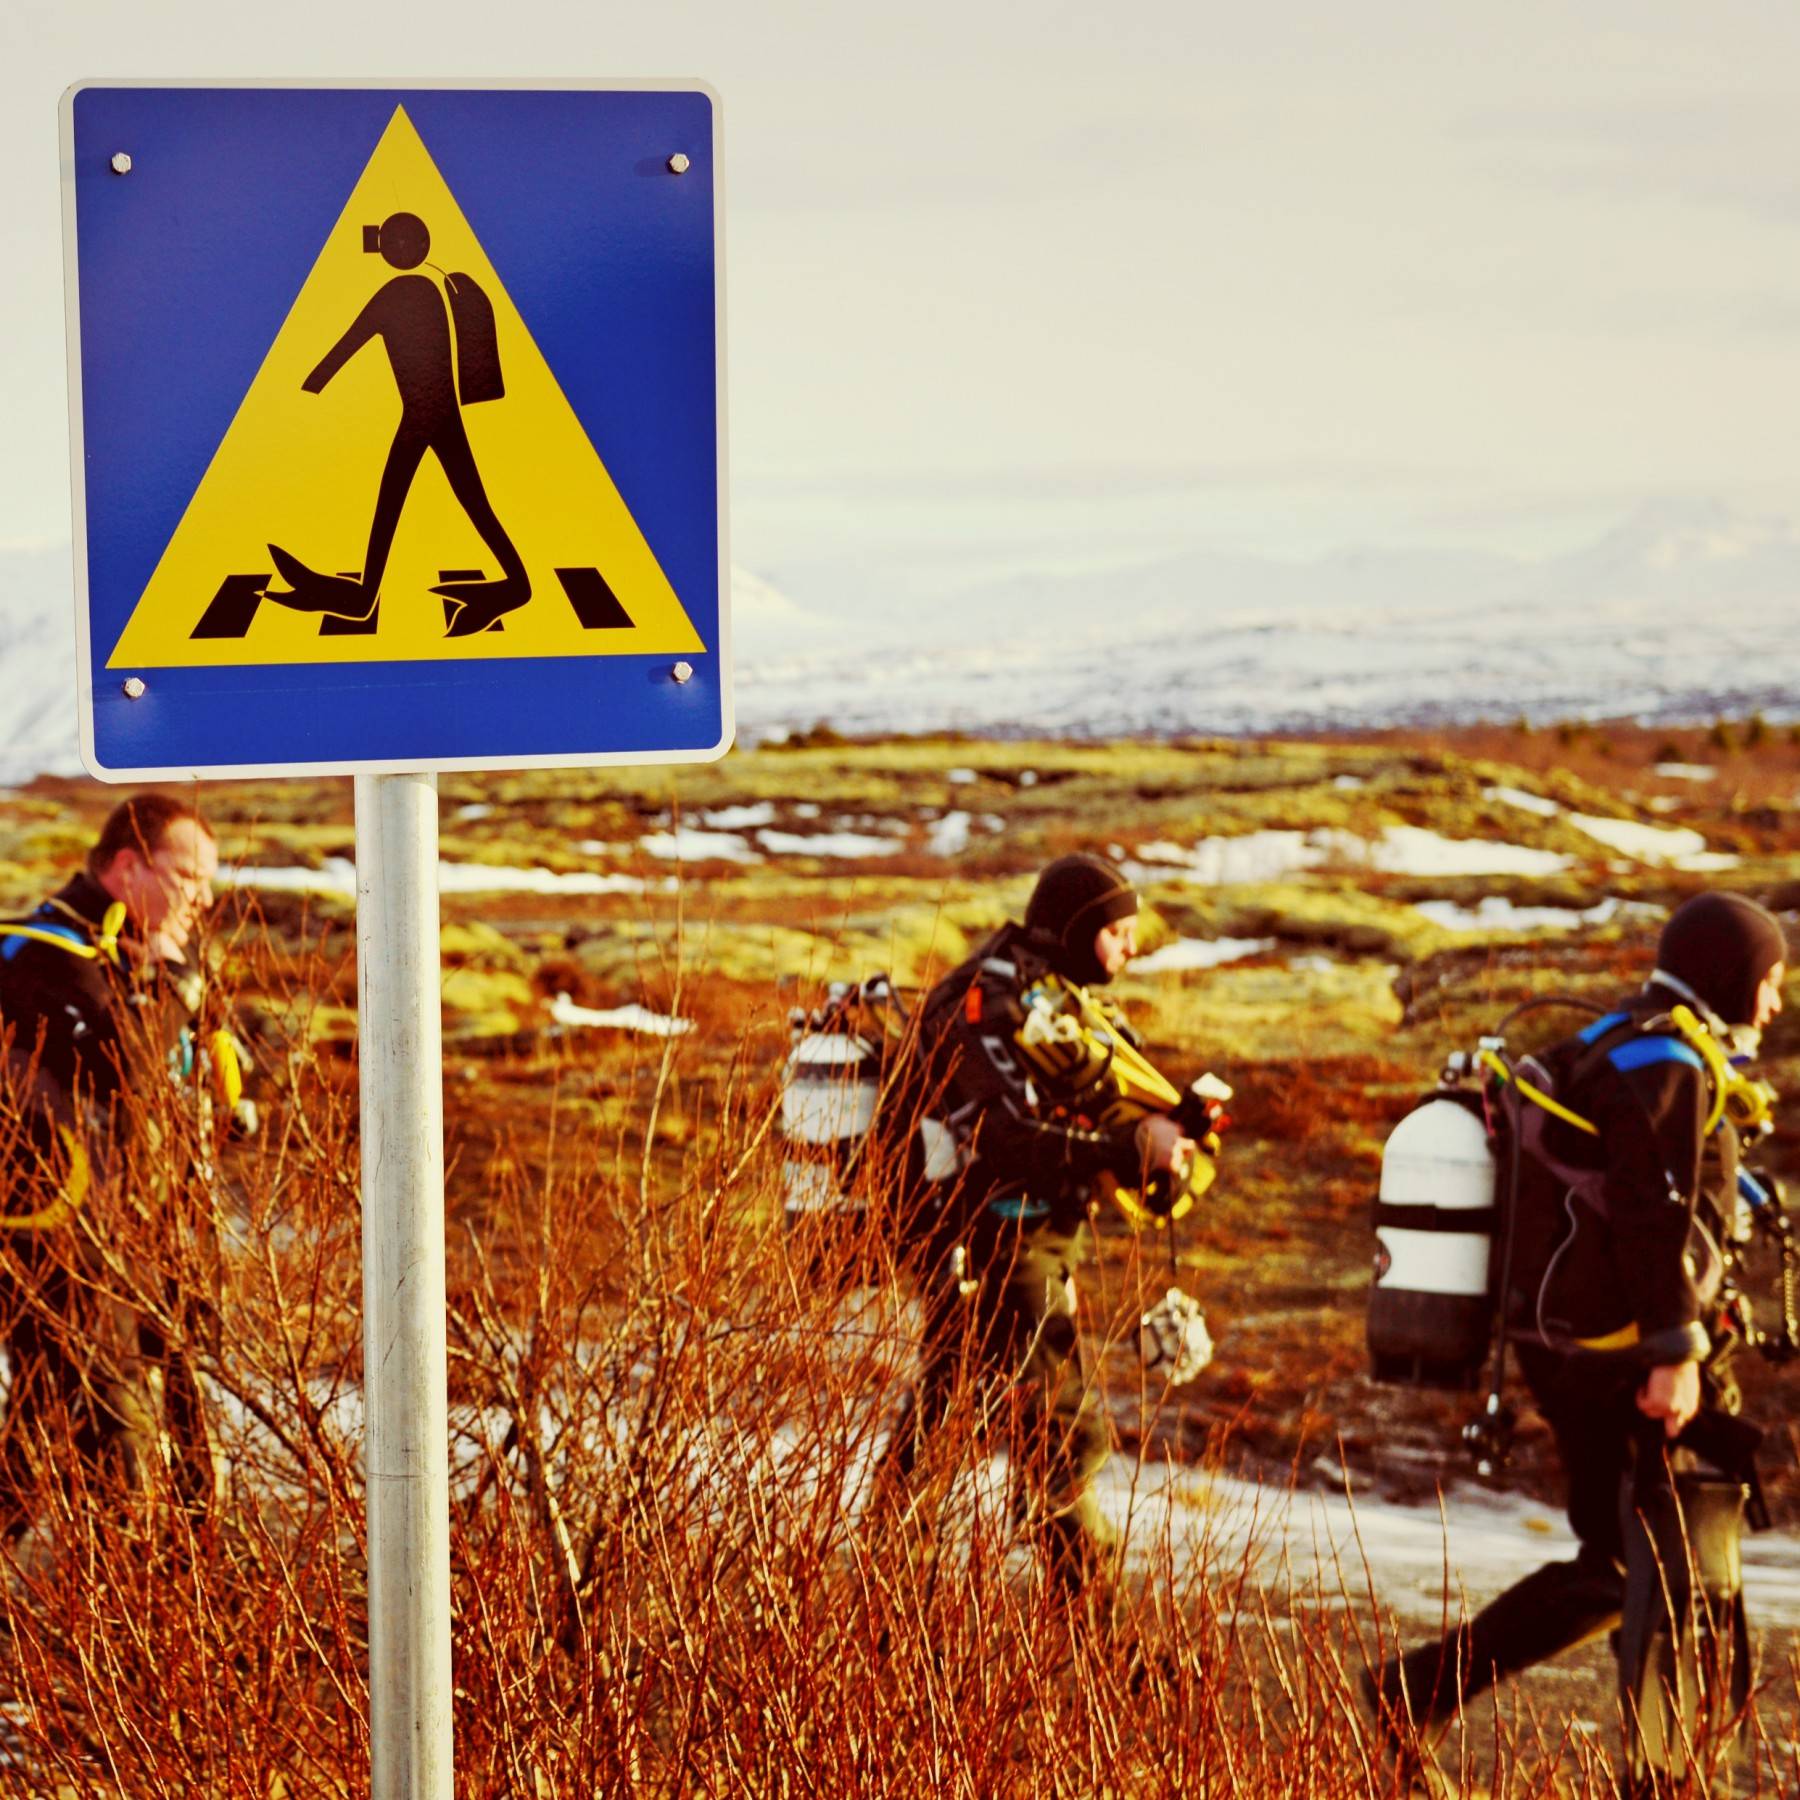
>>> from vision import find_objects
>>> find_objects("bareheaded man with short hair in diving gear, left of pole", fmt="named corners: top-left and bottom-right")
top-left (0, 794), bottom-right (239, 1544)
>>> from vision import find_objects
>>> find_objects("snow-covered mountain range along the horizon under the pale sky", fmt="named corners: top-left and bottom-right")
top-left (0, 502), bottom-right (1800, 781)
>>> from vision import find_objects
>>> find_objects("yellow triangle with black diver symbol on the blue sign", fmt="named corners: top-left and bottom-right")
top-left (108, 106), bottom-right (706, 668)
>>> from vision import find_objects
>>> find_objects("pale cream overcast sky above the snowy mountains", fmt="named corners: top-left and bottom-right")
top-left (0, 0), bottom-right (1800, 604)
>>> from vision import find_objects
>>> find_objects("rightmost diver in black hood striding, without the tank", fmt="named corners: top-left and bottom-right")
top-left (1364, 893), bottom-right (1787, 1795)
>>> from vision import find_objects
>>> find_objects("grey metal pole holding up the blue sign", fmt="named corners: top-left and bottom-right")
top-left (356, 774), bottom-right (450, 1800)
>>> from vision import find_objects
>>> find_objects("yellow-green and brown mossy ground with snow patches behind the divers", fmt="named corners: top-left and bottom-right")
top-left (0, 725), bottom-right (1800, 1496)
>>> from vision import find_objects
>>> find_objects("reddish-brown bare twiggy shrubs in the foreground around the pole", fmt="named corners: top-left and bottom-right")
top-left (0, 921), bottom-right (1778, 1800)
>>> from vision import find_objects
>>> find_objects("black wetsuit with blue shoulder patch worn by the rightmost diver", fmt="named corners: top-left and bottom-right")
top-left (1382, 988), bottom-right (1737, 1721)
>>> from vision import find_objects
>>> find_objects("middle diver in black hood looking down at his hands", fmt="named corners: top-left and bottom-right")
top-left (889, 855), bottom-right (1217, 1627)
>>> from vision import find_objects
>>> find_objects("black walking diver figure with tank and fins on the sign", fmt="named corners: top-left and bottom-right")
top-left (263, 212), bottom-right (531, 637)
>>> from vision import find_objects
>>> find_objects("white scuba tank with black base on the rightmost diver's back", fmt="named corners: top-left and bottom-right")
top-left (1368, 1089), bottom-right (1498, 1388)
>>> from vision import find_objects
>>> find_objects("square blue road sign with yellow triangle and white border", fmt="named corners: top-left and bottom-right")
top-left (63, 85), bottom-right (731, 779)
